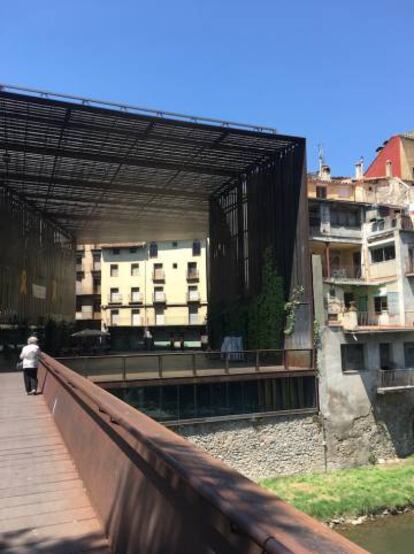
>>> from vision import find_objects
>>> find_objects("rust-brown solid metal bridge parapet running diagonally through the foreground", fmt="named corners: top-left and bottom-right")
top-left (39, 355), bottom-right (365, 554)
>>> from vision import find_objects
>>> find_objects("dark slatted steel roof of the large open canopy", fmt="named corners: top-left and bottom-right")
top-left (0, 85), bottom-right (304, 242)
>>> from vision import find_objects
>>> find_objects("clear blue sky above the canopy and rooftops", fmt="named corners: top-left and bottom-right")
top-left (0, 0), bottom-right (414, 175)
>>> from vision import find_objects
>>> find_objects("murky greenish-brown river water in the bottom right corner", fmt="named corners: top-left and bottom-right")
top-left (339, 513), bottom-right (414, 554)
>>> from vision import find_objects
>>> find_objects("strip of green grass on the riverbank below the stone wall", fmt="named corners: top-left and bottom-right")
top-left (261, 456), bottom-right (414, 521)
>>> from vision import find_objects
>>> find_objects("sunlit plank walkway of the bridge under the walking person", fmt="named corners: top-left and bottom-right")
top-left (0, 373), bottom-right (109, 554)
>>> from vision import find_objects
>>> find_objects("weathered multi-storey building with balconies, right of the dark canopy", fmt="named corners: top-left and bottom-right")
top-left (308, 154), bottom-right (414, 467)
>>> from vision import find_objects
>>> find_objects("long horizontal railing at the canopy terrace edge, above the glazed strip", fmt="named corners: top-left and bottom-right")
top-left (59, 349), bottom-right (315, 381)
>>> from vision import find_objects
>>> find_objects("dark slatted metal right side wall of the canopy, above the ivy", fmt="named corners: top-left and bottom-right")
top-left (209, 143), bottom-right (313, 348)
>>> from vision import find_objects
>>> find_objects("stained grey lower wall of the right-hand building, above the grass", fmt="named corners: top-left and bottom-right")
top-left (319, 308), bottom-right (414, 469)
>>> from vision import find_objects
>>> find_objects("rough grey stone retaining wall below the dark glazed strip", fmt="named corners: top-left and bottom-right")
top-left (174, 414), bottom-right (324, 480)
